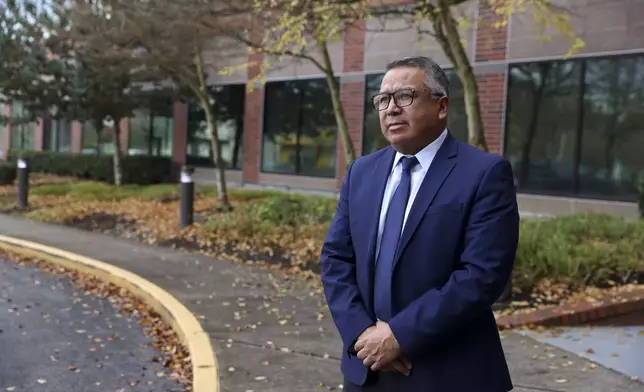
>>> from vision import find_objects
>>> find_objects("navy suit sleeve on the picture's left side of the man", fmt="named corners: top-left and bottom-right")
top-left (321, 161), bottom-right (376, 349)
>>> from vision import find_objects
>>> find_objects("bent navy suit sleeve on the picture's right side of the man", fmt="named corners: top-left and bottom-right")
top-left (389, 159), bottom-right (519, 358)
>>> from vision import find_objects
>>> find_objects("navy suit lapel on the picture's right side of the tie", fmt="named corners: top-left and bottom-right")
top-left (394, 133), bottom-right (458, 267)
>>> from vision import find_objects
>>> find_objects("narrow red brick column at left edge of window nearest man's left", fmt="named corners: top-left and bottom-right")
top-left (242, 19), bottom-right (264, 183)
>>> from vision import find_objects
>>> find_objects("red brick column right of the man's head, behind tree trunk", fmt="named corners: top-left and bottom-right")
top-left (474, 1), bottom-right (508, 154)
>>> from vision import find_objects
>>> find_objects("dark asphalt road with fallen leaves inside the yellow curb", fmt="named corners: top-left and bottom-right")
top-left (0, 256), bottom-right (184, 392)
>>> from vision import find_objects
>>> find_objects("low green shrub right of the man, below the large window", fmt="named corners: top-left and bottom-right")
top-left (513, 213), bottom-right (644, 290)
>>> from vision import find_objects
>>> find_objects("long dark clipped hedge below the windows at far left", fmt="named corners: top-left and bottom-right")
top-left (7, 150), bottom-right (172, 185)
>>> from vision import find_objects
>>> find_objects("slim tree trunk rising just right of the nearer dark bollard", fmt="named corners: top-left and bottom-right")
top-left (195, 33), bottom-right (232, 211)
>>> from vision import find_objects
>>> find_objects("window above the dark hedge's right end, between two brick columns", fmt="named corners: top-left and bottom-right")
top-left (128, 97), bottom-right (174, 156)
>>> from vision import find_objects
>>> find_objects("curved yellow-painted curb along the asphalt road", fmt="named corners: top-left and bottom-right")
top-left (0, 235), bottom-right (219, 392)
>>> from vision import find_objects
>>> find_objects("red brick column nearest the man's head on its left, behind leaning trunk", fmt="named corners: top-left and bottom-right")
top-left (336, 21), bottom-right (366, 186)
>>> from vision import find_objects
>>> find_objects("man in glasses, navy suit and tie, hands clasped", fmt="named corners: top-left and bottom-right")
top-left (321, 57), bottom-right (519, 392)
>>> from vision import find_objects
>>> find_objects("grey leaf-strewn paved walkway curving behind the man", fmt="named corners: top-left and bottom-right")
top-left (0, 216), bottom-right (644, 392)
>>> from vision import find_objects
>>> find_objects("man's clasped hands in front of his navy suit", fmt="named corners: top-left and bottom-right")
top-left (355, 321), bottom-right (401, 371)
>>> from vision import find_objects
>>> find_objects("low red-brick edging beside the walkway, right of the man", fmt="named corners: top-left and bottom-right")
top-left (496, 286), bottom-right (644, 330)
